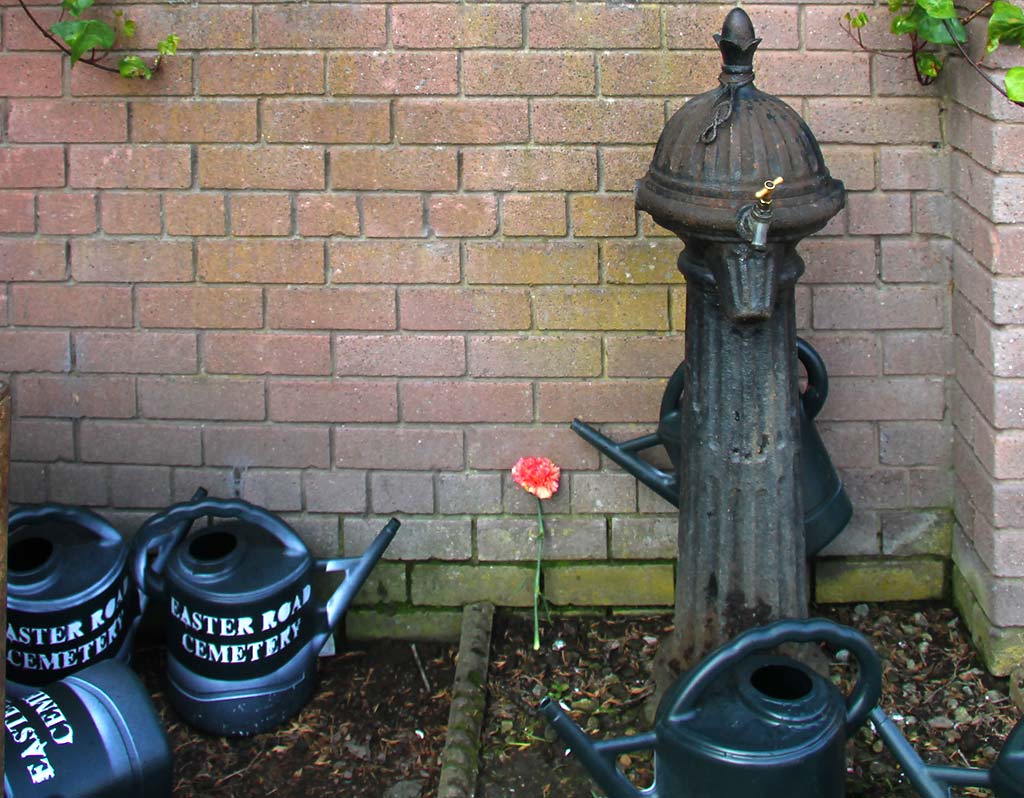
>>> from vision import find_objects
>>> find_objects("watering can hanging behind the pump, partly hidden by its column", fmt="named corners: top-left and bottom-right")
top-left (572, 338), bottom-right (853, 557)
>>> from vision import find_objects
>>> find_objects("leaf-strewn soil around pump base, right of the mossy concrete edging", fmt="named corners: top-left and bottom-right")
top-left (477, 604), bottom-right (1019, 798)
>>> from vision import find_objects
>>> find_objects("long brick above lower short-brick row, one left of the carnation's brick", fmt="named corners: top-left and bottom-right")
top-left (334, 425), bottom-right (464, 471)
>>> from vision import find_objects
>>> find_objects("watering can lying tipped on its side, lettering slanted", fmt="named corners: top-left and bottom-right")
top-left (4, 660), bottom-right (171, 798)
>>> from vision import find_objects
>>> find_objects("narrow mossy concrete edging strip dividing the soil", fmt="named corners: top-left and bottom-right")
top-left (437, 602), bottom-right (495, 798)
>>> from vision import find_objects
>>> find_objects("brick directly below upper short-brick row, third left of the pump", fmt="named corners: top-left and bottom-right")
top-left (328, 241), bottom-right (460, 284)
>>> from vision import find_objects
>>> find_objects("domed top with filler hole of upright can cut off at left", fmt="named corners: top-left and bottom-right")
top-left (7, 519), bottom-right (128, 613)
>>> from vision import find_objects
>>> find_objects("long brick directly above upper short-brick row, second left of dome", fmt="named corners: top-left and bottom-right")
top-left (462, 146), bottom-right (597, 192)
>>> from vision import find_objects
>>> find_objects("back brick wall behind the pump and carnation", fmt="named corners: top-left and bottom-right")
top-left (0, 0), bottom-right (958, 634)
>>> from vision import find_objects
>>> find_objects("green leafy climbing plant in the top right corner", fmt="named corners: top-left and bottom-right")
top-left (841, 0), bottom-right (1024, 106)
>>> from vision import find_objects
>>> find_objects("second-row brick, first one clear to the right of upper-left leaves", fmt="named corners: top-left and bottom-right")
top-left (197, 52), bottom-right (324, 97)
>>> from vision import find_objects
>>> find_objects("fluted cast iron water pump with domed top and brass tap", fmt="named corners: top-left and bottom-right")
top-left (636, 8), bottom-right (846, 672)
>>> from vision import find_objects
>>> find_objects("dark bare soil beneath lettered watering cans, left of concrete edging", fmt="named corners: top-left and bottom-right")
top-left (138, 641), bottom-right (457, 798)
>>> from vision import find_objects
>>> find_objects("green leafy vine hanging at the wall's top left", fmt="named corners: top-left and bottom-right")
top-left (17, 0), bottom-right (178, 80)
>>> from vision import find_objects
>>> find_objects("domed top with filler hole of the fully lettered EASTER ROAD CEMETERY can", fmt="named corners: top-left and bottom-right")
top-left (165, 519), bottom-right (313, 603)
